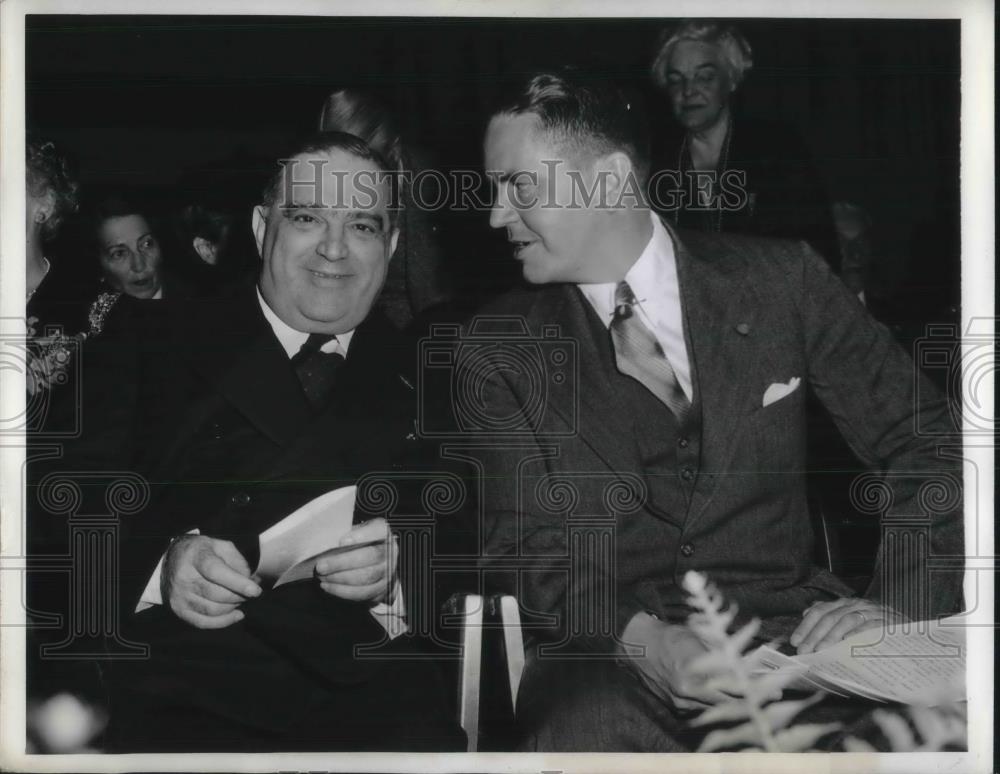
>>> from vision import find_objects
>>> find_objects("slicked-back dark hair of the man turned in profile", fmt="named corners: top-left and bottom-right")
top-left (493, 68), bottom-right (650, 184)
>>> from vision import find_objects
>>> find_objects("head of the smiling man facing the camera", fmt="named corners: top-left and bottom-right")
top-left (253, 132), bottom-right (399, 334)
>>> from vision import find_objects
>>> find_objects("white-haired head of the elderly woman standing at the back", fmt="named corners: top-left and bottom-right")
top-left (652, 19), bottom-right (753, 132)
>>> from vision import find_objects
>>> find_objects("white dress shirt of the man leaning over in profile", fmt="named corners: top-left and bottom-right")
top-left (578, 212), bottom-right (694, 402)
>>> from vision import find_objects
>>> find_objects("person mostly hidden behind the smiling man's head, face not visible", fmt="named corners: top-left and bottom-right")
top-left (319, 89), bottom-right (453, 328)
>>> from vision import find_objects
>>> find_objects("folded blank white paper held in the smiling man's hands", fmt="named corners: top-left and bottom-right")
top-left (257, 486), bottom-right (357, 587)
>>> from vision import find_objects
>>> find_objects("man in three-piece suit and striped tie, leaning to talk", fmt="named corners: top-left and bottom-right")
top-left (472, 74), bottom-right (962, 751)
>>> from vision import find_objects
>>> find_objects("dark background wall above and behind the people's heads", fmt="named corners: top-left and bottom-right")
top-left (26, 16), bottom-right (960, 310)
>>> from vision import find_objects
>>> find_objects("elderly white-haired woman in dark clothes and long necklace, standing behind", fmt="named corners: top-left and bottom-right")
top-left (651, 19), bottom-right (839, 267)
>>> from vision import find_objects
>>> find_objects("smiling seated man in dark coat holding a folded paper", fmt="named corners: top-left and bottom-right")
top-left (30, 132), bottom-right (461, 751)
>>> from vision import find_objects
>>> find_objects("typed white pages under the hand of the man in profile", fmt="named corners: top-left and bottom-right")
top-left (758, 618), bottom-right (966, 706)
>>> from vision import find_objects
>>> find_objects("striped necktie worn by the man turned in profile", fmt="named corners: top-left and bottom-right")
top-left (611, 281), bottom-right (691, 421)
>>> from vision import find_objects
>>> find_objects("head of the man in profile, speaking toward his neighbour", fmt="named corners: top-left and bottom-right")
top-left (485, 73), bottom-right (649, 283)
